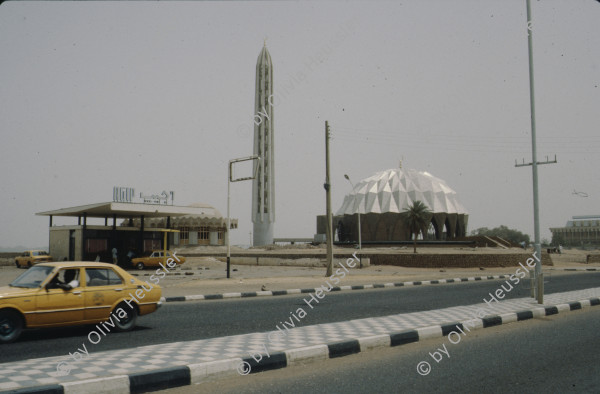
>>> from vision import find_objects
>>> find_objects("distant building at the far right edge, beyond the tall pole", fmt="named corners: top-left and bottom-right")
top-left (550, 215), bottom-right (600, 246)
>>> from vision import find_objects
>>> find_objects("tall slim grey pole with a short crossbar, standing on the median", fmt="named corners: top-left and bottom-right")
top-left (515, 0), bottom-right (557, 304)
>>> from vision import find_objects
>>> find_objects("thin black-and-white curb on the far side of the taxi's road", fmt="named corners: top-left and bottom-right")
top-left (161, 274), bottom-right (510, 302)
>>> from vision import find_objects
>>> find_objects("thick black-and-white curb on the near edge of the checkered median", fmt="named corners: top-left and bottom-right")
top-left (10, 297), bottom-right (600, 394)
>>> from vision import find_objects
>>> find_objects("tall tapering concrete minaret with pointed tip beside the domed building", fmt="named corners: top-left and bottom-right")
top-left (252, 41), bottom-right (275, 246)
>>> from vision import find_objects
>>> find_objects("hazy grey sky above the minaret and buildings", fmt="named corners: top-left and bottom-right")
top-left (0, 0), bottom-right (600, 246)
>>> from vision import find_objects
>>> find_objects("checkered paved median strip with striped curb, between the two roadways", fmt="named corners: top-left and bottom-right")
top-left (0, 287), bottom-right (600, 393)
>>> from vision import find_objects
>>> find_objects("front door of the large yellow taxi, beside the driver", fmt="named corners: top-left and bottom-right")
top-left (31, 268), bottom-right (84, 325)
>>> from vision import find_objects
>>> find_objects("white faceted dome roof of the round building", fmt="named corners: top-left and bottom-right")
top-left (336, 168), bottom-right (468, 215)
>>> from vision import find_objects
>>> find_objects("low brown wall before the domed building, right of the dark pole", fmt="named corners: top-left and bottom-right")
top-left (370, 252), bottom-right (554, 268)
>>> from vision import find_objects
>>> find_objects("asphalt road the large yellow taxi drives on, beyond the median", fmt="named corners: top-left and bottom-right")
top-left (0, 272), bottom-right (600, 363)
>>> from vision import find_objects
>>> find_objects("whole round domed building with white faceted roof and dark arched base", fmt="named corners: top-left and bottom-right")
top-left (317, 168), bottom-right (468, 242)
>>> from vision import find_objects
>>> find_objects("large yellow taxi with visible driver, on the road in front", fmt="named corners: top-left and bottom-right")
top-left (0, 262), bottom-right (162, 344)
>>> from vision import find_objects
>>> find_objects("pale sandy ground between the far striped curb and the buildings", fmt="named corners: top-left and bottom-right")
top-left (0, 248), bottom-right (600, 297)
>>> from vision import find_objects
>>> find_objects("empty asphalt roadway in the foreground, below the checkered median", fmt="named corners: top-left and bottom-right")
top-left (165, 307), bottom-right (600, 394)
